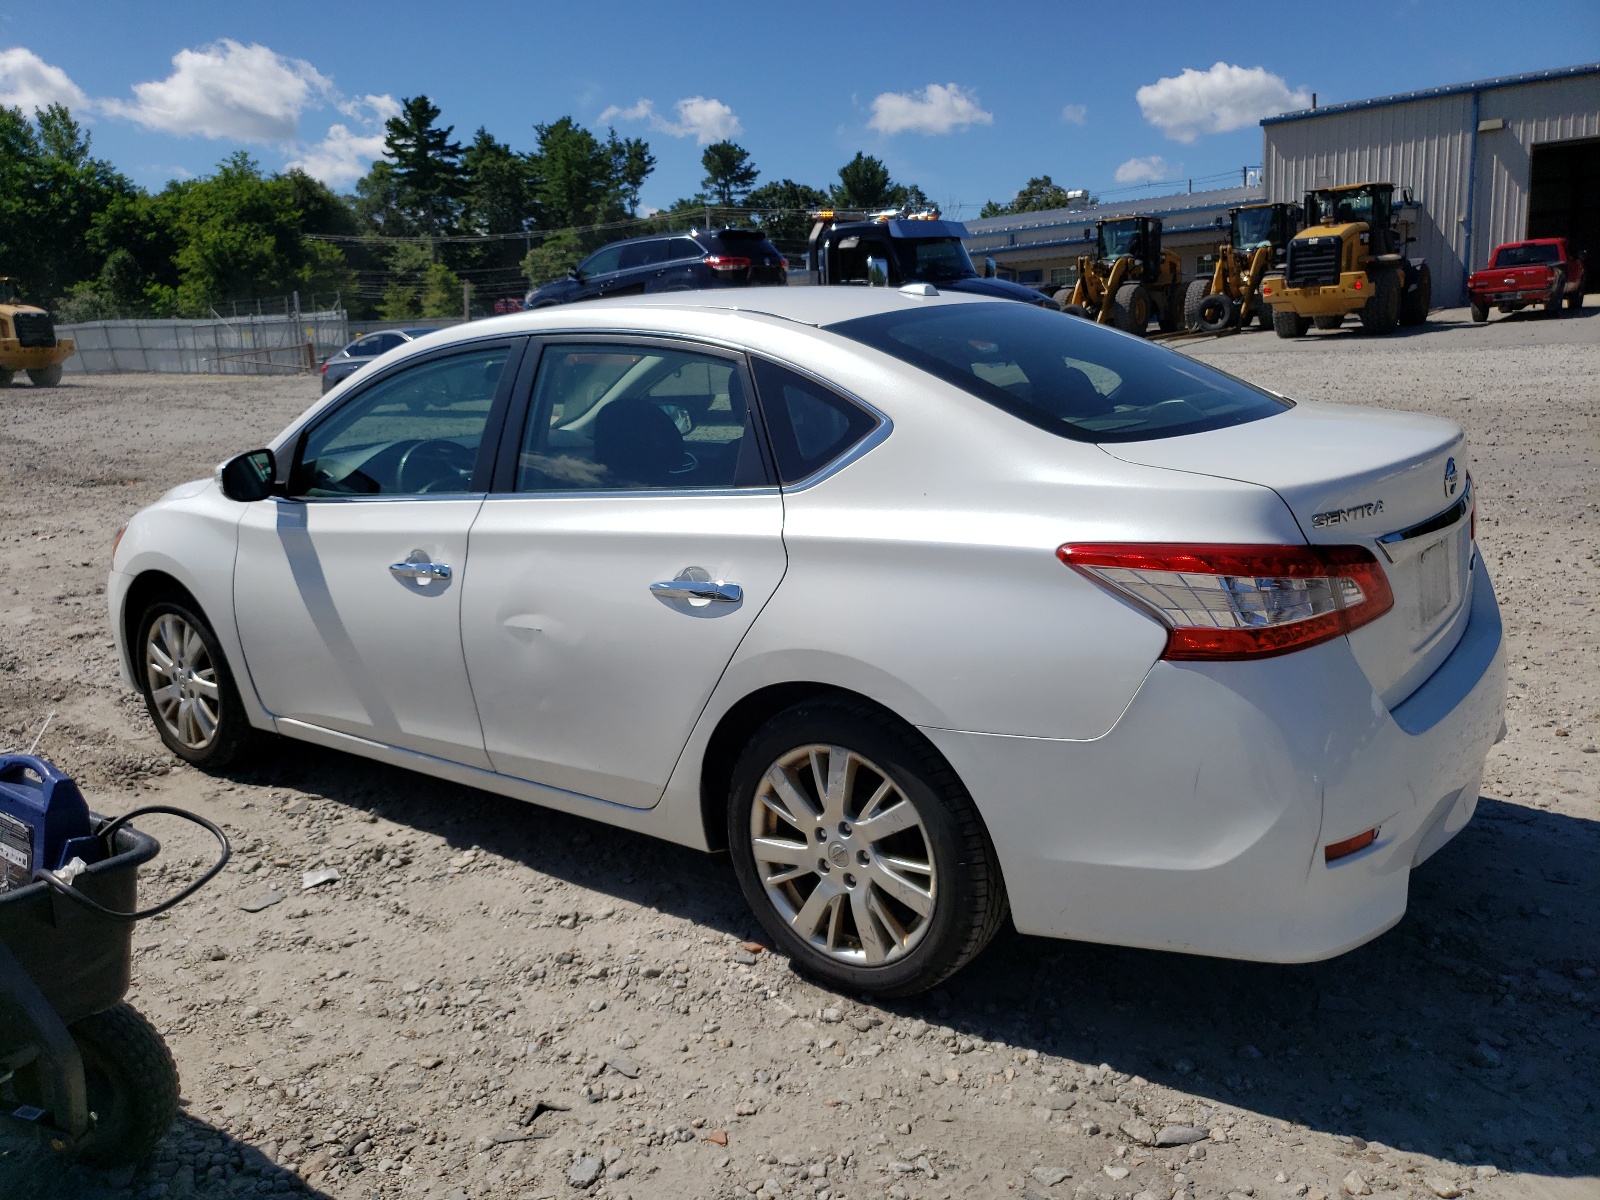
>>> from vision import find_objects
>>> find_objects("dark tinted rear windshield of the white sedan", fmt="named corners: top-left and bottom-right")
top-left (827, 301), bottom-right (1290, 442)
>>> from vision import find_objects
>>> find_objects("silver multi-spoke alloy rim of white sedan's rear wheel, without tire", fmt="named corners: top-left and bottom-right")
top-left (750, 744), bottom-right (939, 966)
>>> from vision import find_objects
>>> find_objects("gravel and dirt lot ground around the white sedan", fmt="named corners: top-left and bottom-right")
top-left (0, 306), bottom-right (1600, 1200)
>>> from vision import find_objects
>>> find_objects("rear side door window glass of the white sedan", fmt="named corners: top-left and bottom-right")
top-left (515, 342), bottom-right (766, 493)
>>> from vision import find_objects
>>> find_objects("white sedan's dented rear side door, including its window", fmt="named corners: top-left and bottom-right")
top-left (462, 338), bottom-right (786, 808)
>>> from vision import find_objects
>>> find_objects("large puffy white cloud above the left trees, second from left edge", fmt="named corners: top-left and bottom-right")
top-left (102, 38), bottom-right (339, 142)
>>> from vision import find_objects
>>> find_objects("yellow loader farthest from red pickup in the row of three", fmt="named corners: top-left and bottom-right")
top-left (1056, 216), bottom-right (1184, 338)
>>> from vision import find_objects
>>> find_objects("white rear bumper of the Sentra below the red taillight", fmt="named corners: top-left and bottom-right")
top-left (925, 565), bottom-right (1504, 962)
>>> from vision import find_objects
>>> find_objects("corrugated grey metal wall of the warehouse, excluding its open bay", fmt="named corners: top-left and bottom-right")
top-left (1262, 75), bottom-right (1600, 307)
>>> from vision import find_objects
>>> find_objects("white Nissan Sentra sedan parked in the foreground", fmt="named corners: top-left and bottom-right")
top-left (107, 285), bottom-right (1504, 995)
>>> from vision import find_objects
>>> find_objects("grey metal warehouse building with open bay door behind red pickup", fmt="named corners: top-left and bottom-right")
top-left (1261, 62), bottom-right (1600, 307)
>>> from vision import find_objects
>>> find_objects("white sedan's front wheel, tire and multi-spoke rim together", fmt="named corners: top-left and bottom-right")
top-left (131, 597), bottom-right (261, 771)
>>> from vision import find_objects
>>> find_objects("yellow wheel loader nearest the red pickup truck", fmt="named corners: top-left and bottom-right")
top-left (1261, 184), bottom-right (1434, 338)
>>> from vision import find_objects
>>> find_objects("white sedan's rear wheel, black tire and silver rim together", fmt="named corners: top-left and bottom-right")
top-left (728, 699), bottom-right (1008, 997)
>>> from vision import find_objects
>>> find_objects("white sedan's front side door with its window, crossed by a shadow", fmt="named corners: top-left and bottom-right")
top-left (234, 341), bottom-right (522, 766)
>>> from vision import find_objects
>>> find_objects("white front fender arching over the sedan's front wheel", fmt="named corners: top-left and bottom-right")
top-left (106, 480), bottom-right (274, 730)
